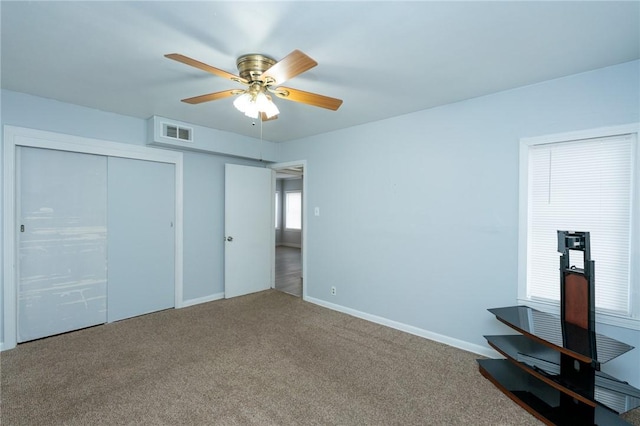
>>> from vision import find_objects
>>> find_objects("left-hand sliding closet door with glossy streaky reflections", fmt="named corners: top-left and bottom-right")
top-left (16, 147), bottom-right (107, 342)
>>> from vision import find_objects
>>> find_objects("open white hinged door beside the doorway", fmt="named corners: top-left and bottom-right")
top-left (224, 164), bottom-right (275, 298)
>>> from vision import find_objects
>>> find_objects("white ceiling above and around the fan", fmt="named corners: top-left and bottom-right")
top-left (0, 1), bottom-right (640, 142)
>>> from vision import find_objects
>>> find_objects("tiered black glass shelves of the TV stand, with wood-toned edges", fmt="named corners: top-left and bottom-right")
top-left (478, 306), bottom-right (640, 426)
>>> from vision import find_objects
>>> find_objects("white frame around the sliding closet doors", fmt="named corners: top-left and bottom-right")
top-left (0, 126), bottom-right (183, 351)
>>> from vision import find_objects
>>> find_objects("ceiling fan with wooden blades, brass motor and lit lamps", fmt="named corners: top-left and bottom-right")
top-left (164, 50), bottom-right (342, 121)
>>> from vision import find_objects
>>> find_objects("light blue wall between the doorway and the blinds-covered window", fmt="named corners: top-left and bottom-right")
top-left (279, 61), bottom-right (640, 386)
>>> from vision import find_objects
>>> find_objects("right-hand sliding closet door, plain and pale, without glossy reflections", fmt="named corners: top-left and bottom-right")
top-left (108, 157), bottom-right (175, 322)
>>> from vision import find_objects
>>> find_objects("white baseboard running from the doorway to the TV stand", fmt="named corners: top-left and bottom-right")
top-left (305, 297), bottom-right (503, 358)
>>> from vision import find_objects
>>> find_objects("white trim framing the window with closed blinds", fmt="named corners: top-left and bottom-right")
top-left (518, 123), bottom-right (640, 330)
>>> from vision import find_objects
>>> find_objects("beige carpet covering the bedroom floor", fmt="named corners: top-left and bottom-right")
top-left (0, 291), bottom-right (640, 426)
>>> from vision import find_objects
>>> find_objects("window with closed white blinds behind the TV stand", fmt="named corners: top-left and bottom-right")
top-left (519, 124), bottom-right (640, 328)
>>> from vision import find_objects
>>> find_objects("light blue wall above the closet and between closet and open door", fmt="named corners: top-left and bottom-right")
top-left (0, 90), bottom-right (265, 326)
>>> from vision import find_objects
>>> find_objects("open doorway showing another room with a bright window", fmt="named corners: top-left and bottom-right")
top-left (272, 163), bottom-right (306, 297)
